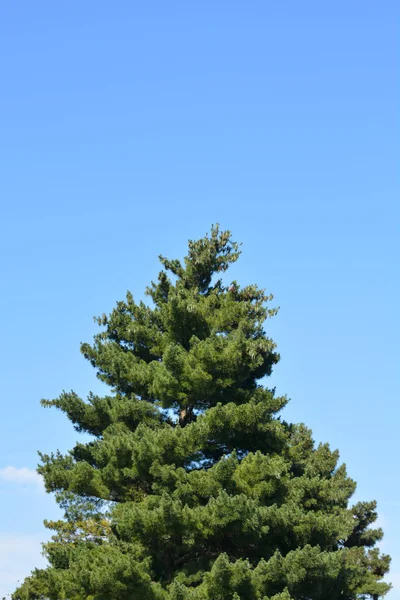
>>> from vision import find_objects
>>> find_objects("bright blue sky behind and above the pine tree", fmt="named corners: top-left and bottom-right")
top-left (0, 0), bottom-right (400, 600)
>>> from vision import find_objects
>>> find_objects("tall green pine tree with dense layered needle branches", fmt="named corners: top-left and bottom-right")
top-left (13, 227), bottom-right (390, 600)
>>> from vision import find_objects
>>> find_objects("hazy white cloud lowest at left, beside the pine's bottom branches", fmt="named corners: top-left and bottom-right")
top-left (0, 533), bottom-right (46, 598)
